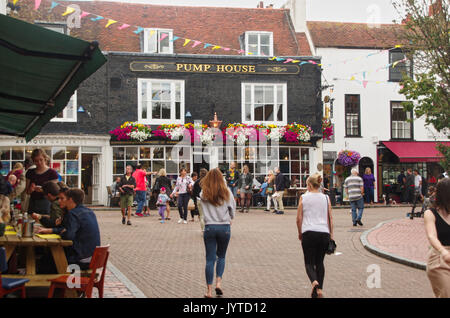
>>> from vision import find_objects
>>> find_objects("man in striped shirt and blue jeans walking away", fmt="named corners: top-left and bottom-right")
top-left (344, 168), bottom-right (364, 226)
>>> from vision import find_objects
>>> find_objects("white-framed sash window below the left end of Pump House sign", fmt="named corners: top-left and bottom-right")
top-left (138, 78), bottom-right (184, 125)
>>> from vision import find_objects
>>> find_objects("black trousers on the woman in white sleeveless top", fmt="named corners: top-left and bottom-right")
top-left (302, 231), bottom-right (330, 289)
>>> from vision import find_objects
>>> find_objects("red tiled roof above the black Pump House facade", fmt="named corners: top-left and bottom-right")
top-left (12, 0), bottom-right (311, 56)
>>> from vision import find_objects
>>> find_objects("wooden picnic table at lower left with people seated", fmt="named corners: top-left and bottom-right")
top-left (0, 234), bottom-right (72, 287)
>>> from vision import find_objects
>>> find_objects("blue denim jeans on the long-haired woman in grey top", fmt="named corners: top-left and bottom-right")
top-left (203, 224), bottom-right (231, 285)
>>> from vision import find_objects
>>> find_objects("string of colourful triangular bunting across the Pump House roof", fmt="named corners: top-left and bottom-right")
top-left (17, 0), bottom-right (322, 66)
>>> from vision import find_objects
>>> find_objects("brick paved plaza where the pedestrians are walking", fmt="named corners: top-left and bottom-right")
top-left (96, 208), bottom-right (433, 298)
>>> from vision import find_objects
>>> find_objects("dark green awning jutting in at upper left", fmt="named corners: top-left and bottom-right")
top-left (0, 14), bottom-right (106, 141)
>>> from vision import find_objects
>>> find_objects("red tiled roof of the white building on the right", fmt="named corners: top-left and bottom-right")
top-left (307, 21), bottom-right (406, 49)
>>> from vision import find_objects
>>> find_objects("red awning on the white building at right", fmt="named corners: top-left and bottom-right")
top-left (383, 141), bottom-right (450, 162)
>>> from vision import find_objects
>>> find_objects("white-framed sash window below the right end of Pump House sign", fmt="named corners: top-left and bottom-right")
top-left (242, 83), bottom-right (287, 125)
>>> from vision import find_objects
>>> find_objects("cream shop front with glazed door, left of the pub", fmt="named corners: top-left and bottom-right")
top-left (0, 135), bottom-right (110, 205)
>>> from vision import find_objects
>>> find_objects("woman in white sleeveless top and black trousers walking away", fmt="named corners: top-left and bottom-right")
top-left (297, 173), bottom-right (333, 298)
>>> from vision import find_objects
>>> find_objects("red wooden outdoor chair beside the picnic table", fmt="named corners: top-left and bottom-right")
top-left (48, 245), bottom-right (109, 298)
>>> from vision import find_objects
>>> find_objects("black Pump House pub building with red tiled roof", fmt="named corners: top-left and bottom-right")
top-left (5, 0), bottom-right (323, 205)
